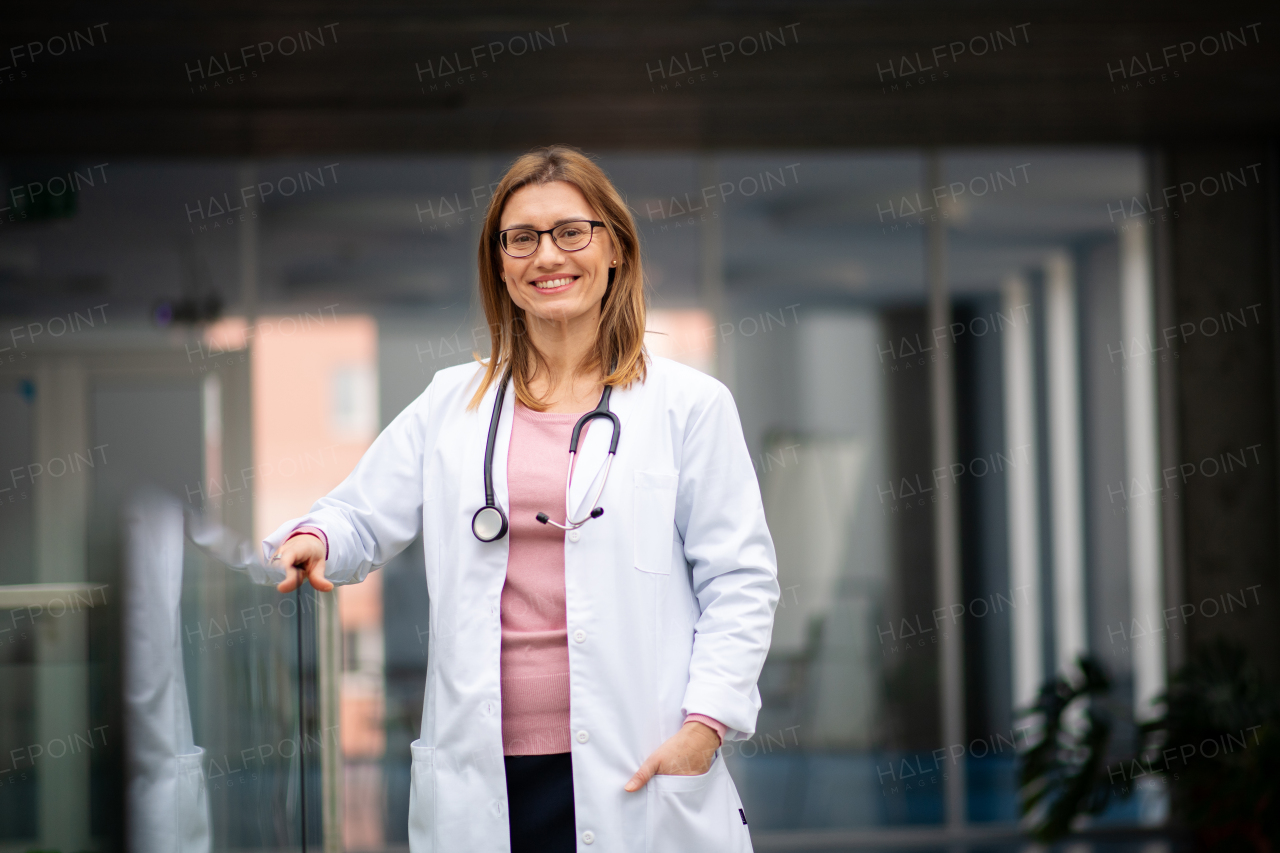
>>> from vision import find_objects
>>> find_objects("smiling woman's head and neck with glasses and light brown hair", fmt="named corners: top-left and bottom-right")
top-left (470, 146), bottom-right (645, 412)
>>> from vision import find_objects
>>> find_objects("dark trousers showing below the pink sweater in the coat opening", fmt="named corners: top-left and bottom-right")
top-left (504, 752), bottom-right (577, 853)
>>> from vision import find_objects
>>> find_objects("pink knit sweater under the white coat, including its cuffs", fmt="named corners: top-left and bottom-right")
top-left (291, 401), bottom-right (728, 756)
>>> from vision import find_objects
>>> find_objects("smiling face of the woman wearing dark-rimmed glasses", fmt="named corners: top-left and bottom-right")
top-left (498, 181), bottom-right (620, 328)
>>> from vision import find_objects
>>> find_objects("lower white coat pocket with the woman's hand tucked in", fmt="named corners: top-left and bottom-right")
top-left (649, 752), bottom-right (751, 853)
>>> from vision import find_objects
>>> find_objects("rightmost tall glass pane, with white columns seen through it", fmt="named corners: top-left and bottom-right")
top-left (938, 150), bottom-right (1158, 821)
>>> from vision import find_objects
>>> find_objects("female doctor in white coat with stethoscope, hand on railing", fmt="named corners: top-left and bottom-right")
top-left (264, 146), bottom-right (778, 853)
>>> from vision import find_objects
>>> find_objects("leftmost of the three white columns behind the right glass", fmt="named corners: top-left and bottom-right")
top-left (1001, 275), bottom-right (1044, 708)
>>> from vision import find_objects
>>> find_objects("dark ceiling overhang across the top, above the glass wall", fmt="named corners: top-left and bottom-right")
top-left (0, 1), bottom-right (1280, 156)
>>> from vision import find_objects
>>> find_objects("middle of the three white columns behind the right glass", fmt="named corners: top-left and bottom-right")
top-left (1044, 252), bottom-right (1088, 672)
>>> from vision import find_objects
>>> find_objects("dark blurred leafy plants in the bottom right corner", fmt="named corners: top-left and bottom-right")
top-left (1019, 639), bottom-right (1280, 853)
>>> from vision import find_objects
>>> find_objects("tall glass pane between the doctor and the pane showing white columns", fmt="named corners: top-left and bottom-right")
top-left (716, 154), bottom-right (942, 831)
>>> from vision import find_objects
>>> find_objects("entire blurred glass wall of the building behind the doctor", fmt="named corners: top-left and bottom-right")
top-left (0, 150), bottom-right (1153, 849)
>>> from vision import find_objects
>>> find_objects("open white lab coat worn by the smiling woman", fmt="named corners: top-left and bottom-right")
top-left (264, 357), bottom-right (778, 853)
